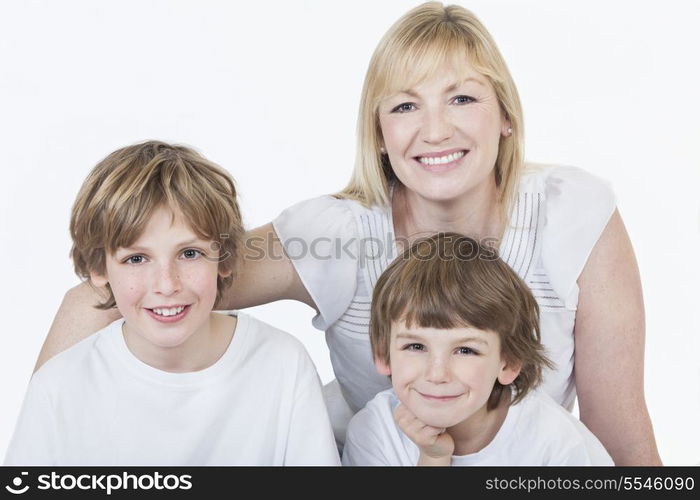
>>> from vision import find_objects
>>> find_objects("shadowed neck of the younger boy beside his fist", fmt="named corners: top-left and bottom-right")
top-left (447, 388), bottom-right (510, 455)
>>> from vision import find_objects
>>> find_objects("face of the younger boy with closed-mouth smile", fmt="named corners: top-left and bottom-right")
top-left (376, 321), bottom-right (519, 428)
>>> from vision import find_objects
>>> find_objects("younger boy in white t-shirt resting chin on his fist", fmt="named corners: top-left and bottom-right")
top-left (343, 233), bottom-right (613, 465)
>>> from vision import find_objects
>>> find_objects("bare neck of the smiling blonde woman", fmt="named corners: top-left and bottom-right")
top-left (392, 181), bottom-right (503, 250)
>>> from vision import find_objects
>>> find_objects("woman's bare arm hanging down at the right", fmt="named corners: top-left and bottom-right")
top-left (574, 211), bottom-right (661, 465)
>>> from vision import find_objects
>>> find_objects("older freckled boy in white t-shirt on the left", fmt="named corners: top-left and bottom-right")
top-left (6, 141), bottom-right (339, 465)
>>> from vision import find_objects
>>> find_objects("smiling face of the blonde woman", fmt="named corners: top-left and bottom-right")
top-left (379, 61), bottom-right (509, 201)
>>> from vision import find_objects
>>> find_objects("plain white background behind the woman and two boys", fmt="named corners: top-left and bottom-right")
top-left (0, 0), bottom-right (700, 464)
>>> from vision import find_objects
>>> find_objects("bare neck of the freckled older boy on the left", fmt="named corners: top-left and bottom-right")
top-left (122, 313), bottom-right (237, 373)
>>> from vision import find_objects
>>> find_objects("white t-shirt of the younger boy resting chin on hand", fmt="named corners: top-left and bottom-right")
top-left (343, 389), bottom-right (613, 465)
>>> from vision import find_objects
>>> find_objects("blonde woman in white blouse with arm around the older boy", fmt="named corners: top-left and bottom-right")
top-left (39, 2), bottom-right (660, 465)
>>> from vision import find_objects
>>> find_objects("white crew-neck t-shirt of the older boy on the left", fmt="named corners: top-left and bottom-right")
top-left (5, 313), bottom-right (339, 465)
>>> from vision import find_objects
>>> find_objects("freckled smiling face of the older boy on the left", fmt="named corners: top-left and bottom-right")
top-left (91, 206), bottom-right (226, 357)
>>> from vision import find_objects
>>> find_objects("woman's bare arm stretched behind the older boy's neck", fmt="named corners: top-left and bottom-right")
top-left (34, 224), bottom-right (315, 370)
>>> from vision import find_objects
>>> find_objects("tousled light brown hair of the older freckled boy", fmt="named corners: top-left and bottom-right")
top-left (70, 141), bottom-right (243, 309)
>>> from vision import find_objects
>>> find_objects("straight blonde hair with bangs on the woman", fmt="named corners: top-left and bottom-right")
top-left (336, 2), bottom-right (524, 219)
